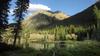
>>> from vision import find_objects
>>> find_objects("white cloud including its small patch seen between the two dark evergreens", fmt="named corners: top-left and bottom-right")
top-left (9, 3), bottom-right (51, 16)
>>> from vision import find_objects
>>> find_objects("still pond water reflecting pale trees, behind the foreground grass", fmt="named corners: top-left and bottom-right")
top-left (26, 41), bottom-right (66, 49)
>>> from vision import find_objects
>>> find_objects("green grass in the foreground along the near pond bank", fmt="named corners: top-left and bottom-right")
top-left (1, 40), bottom-right (100, 56)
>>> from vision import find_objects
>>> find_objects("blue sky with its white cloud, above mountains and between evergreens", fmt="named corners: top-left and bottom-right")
top-left (9, 0), bottom-right (96, 23)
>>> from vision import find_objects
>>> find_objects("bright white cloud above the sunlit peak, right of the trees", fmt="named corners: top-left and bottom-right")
top-left (28, 3), bottom-right (51, 12)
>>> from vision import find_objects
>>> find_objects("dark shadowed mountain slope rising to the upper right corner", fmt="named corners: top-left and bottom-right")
top-left (62, 2), bottom-right (100, 25)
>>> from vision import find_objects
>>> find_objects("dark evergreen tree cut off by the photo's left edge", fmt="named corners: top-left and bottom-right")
top-left (0, 0), bottom-right (11, 40)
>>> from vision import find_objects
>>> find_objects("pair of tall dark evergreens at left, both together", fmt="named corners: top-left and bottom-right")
top-left (0, 0), bottom-right (29, 46)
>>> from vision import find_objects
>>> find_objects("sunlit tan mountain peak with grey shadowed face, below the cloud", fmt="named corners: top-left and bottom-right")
top-left (22, 10), bottom-right (70, 29)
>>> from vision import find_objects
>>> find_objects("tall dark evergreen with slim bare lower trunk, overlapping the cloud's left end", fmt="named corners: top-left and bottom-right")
top-left (13, 0), bottom-right (29, 46)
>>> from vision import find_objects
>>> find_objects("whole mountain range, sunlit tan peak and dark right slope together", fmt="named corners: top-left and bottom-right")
top-left (22, 2), bottom-right (100, 29)
